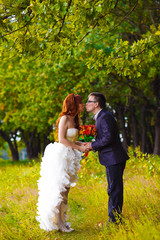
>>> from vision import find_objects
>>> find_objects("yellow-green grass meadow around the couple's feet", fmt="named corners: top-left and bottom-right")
top-left (0, 154), bottom-right (160, 240)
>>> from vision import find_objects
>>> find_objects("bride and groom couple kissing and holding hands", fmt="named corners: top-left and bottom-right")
top-left (36, 92), bottom-right (128, 232)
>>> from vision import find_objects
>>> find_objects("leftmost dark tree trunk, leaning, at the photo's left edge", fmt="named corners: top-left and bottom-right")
top-left (0, 130), bottom-right (19, 162)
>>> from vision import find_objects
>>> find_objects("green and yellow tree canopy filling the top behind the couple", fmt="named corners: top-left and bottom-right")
top-left (0, 0), bottom-right (160, 158)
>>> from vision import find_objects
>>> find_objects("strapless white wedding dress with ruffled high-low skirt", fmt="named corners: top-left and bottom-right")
top-left (36, 128), bottom-right (82, 231)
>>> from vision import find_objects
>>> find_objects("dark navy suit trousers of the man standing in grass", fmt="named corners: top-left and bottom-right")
top-left (106, 162), bottom-right (126, 223)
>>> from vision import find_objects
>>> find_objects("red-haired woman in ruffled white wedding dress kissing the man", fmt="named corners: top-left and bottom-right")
top-left (36, 94), bottom-right (85, 232)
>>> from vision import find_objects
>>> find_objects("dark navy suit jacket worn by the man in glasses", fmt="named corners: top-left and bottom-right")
top-left (92, 109), bottom-right (129, 167)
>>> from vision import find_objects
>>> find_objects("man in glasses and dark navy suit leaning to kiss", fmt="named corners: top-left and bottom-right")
top-left (86, 92), bottom-right (128, 224)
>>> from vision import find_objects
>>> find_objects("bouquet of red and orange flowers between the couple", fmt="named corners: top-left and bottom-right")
top-left (79, 125), bottom-right (97, 157)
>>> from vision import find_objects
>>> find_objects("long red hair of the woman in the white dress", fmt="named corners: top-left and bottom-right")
top-left (56, 93), bottom-right (82, 128)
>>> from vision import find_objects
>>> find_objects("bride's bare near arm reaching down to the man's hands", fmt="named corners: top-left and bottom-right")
top-left (58, 116), bottom-right (85, 152)
